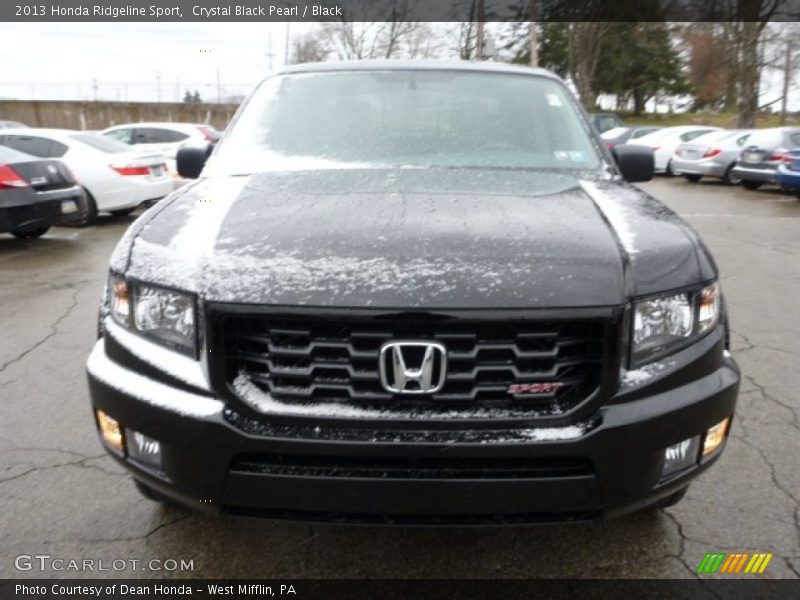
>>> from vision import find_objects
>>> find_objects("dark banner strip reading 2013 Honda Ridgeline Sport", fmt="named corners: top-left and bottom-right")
top-left (0, 0), bottom-right (800, 22)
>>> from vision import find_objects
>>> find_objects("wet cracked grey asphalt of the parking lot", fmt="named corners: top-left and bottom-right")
top-left (0, 178), bottom-right (800, 578)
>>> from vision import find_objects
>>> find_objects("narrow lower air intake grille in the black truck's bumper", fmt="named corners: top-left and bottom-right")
top-left (231, 454), bottom-right (594, 479)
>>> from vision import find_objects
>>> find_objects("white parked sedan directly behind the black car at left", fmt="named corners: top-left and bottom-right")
top-left (0, 128), bottom-right (174, 223)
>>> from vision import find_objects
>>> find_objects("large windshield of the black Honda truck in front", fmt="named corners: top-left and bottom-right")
top-left (207, 70), bottom-right (600, 174)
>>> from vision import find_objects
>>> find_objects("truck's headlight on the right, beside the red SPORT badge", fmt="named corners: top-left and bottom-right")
top-left (631, 283), bottom-right (720, 367)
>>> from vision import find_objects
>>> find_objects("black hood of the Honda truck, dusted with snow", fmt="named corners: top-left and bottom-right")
top-left (118, 169), bottom-right (712, 308)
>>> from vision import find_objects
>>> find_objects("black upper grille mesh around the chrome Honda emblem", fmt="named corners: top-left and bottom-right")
top-left (222, 314), bottom-right (605, 415)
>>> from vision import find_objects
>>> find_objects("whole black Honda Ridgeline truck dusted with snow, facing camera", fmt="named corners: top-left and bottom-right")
top-left (87, 61), bottom-right (739, 524)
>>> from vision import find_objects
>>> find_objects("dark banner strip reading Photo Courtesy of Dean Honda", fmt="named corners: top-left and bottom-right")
top-left (0, 578), bottom-right (800, 600)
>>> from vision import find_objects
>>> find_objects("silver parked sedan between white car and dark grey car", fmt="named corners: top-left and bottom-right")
top-left (672, 129), bottom-right (752, 185)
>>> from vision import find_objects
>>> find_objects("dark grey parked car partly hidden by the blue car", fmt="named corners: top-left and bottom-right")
top-left (732, 127), bottom-right (800, 190)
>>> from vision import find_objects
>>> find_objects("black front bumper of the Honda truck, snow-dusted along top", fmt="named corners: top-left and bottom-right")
top-left (88, 328), bottom-right (739, 525)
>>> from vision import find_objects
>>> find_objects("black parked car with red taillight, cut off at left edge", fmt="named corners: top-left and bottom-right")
top-left (0, 146), bottom-right (87, 238)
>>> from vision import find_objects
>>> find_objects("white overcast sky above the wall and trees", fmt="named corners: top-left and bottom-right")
top-left (0, 22), bottom-right (800, 110)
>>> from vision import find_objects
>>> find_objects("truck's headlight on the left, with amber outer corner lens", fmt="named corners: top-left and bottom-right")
top-left (109, 277), bottom-right (197, 355)
